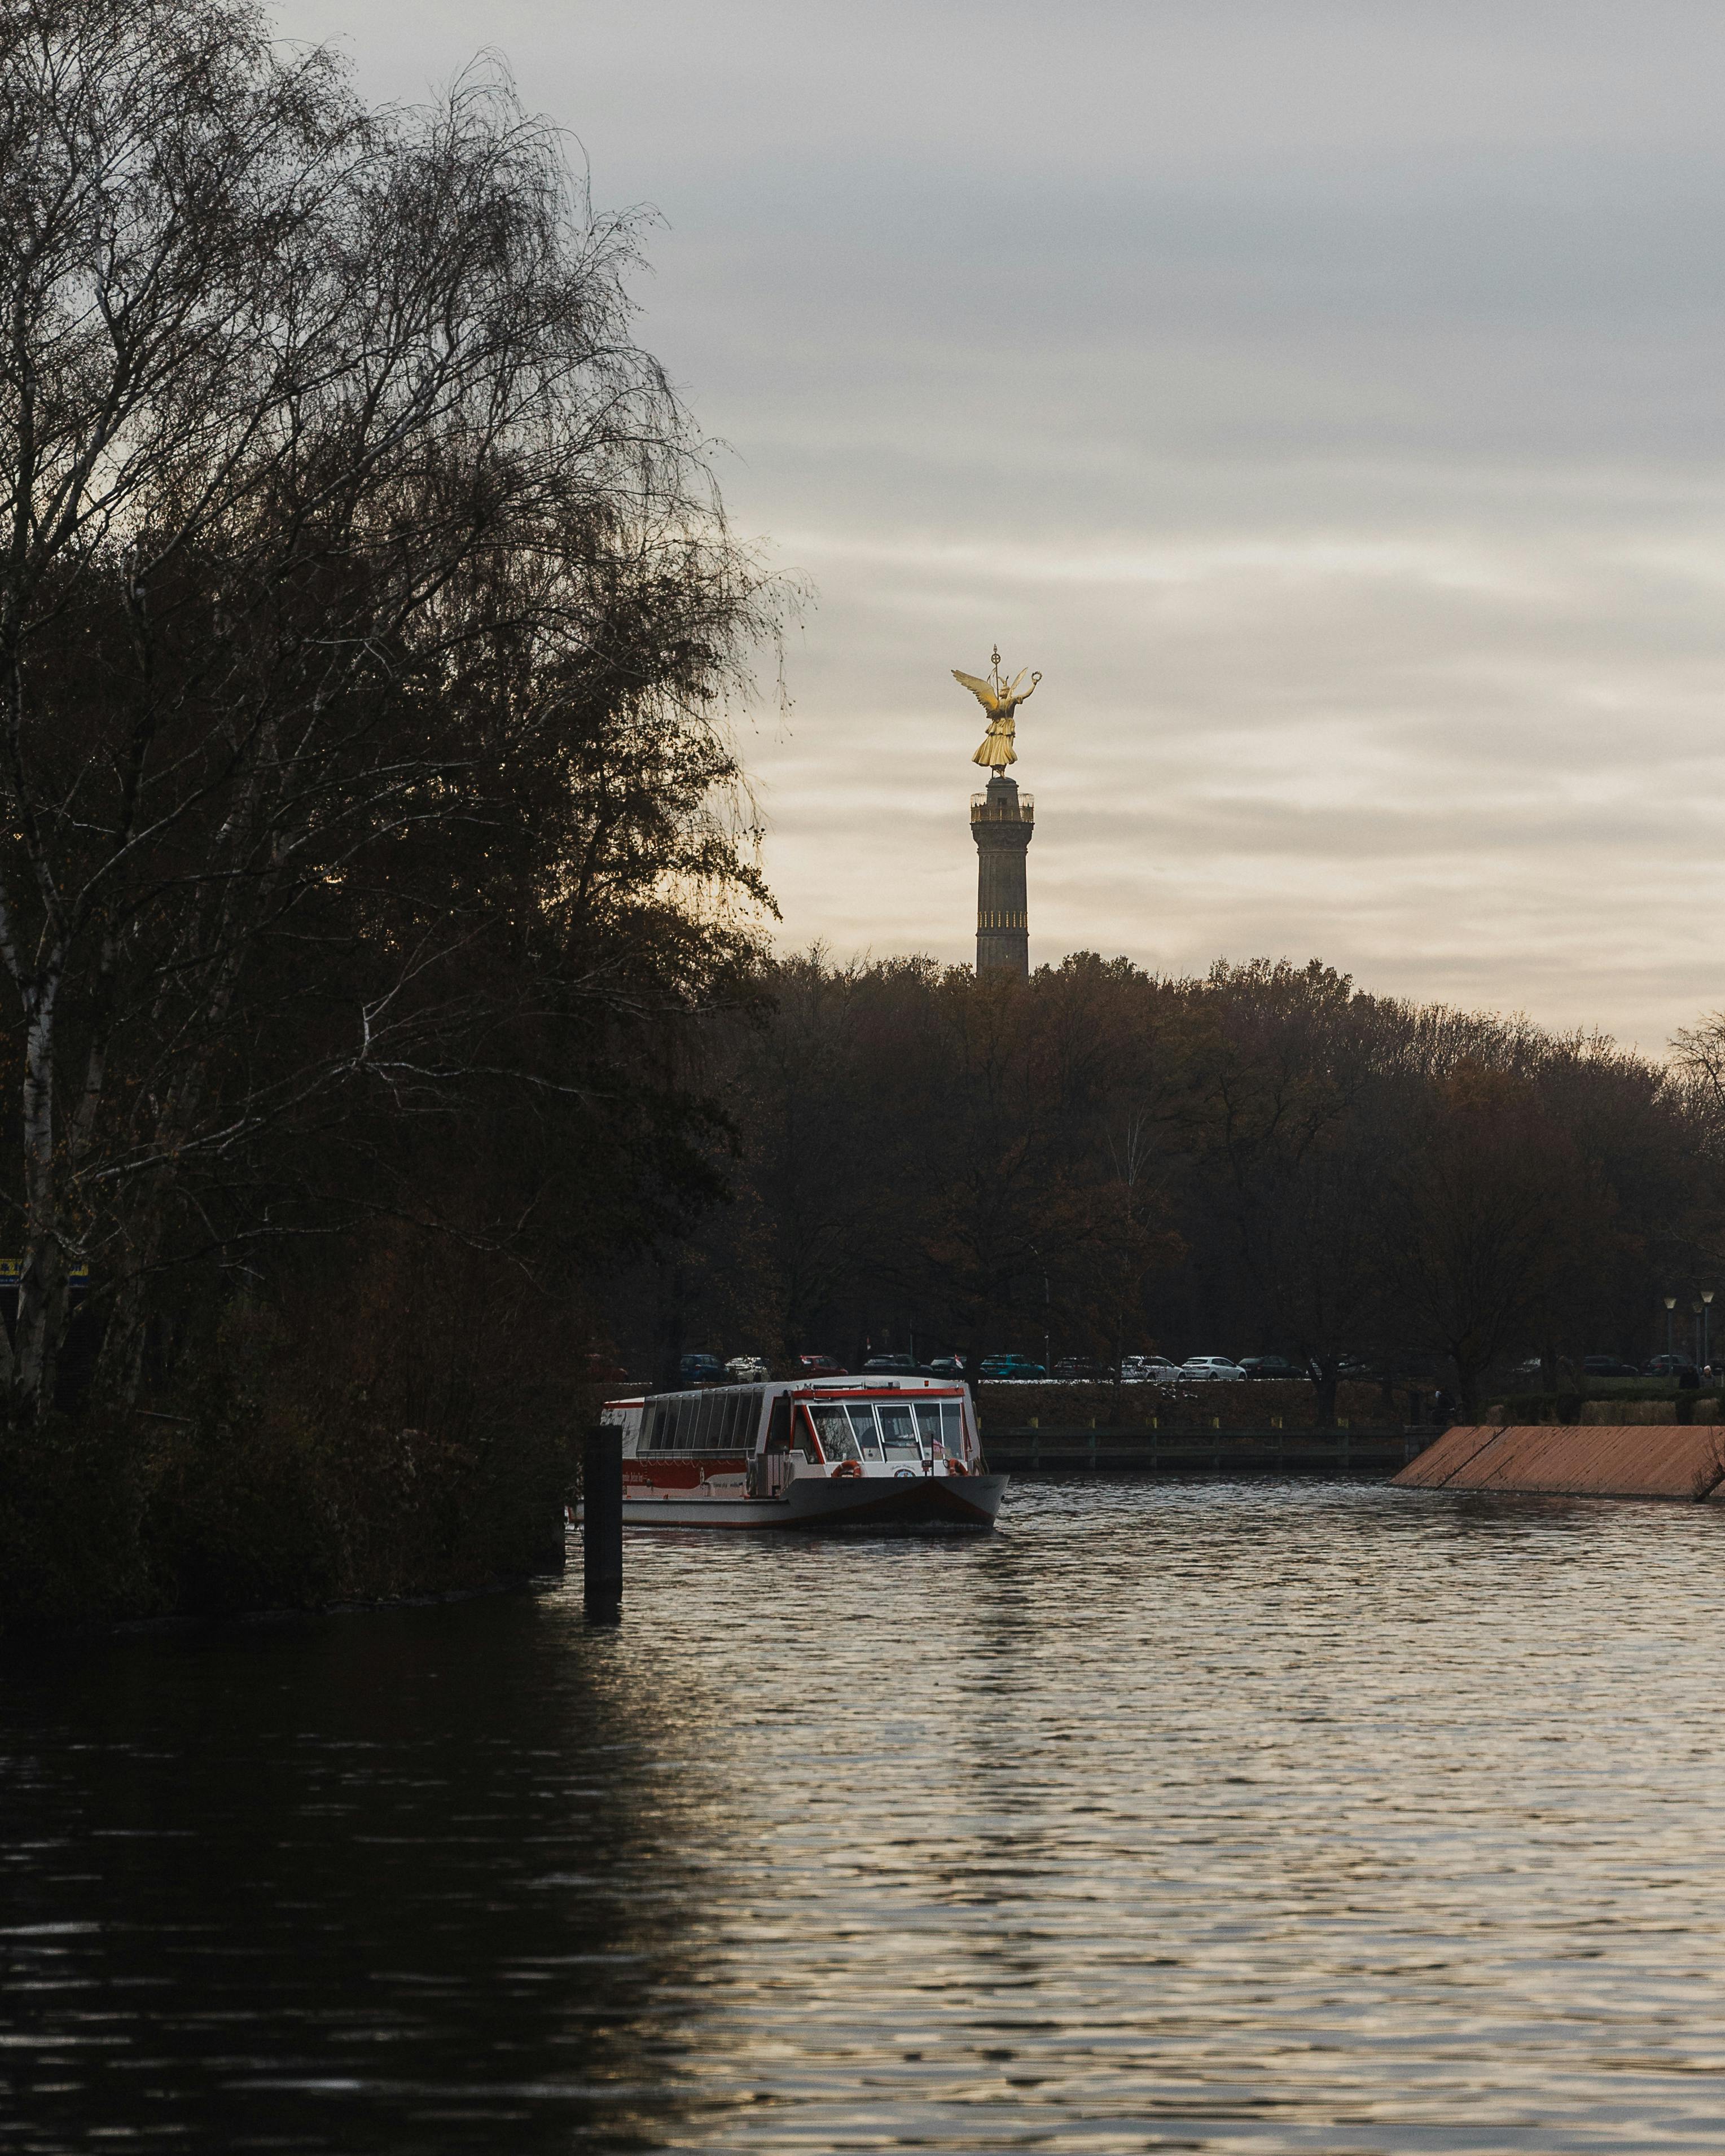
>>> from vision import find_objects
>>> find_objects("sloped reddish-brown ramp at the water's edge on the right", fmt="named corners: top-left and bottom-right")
top-left (1395, 1423), bottom-right (1725, 1503)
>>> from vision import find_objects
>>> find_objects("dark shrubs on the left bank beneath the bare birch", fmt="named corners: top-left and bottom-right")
top-left (0, 1237), bottom-right (585, 1628)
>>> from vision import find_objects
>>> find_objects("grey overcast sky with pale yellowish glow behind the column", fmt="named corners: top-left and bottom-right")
top-left (276, 0), bottom-right (1725, 1050)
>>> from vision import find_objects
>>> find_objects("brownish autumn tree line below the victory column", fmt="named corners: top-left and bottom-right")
top-left (619, 953), bottom-right (1725, 1416)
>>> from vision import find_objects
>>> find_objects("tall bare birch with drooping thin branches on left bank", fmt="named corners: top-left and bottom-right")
top-left (0, 0), bottom-right (776, 1416)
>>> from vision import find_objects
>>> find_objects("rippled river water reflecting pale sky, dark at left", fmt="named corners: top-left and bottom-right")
top-left (0, 1481), bottom-right (1725, 2156)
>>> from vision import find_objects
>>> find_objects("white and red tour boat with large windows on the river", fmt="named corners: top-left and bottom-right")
top-left (599, 1373), bottom-right (1007, 1526)
